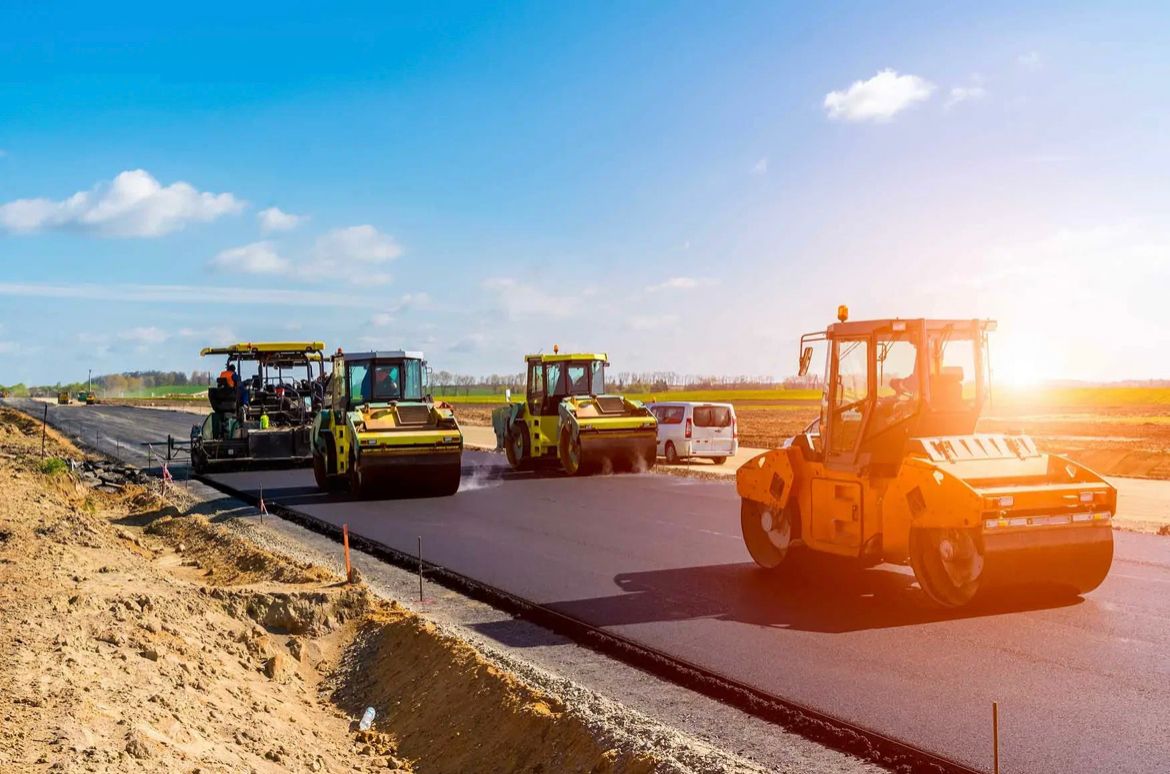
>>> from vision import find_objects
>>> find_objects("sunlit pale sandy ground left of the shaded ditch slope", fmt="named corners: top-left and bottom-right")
top-left (0, 413), bottom-right (410, 772)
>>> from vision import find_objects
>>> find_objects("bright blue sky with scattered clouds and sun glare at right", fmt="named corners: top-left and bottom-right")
top-left (0, 4), bottom-right (1170, 382)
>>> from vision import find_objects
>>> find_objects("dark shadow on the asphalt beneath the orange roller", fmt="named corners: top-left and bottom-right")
top-left (535, 562), bottom-right (1083, 634)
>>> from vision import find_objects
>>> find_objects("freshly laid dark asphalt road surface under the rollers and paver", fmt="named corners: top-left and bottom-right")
top-left (11, 406), bottom-right (1170, 772)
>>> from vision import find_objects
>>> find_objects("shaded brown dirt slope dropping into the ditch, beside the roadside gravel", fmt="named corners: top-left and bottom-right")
top-left (331, 606), bottom-right (655, 773)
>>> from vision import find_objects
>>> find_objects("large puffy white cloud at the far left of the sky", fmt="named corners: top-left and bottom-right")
top-left (0, 170), bottom-right (246, 237)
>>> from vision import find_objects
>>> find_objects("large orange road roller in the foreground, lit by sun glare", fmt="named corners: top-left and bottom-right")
top-left (736, 306), bottom-right (1117, 608)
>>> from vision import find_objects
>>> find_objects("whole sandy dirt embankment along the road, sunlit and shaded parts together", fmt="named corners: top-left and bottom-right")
top-left (0, 410), bottom-right (702, 772)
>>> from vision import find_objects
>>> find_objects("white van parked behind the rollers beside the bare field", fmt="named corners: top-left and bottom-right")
top-left (646, 401), bottom-right (739, 465)
